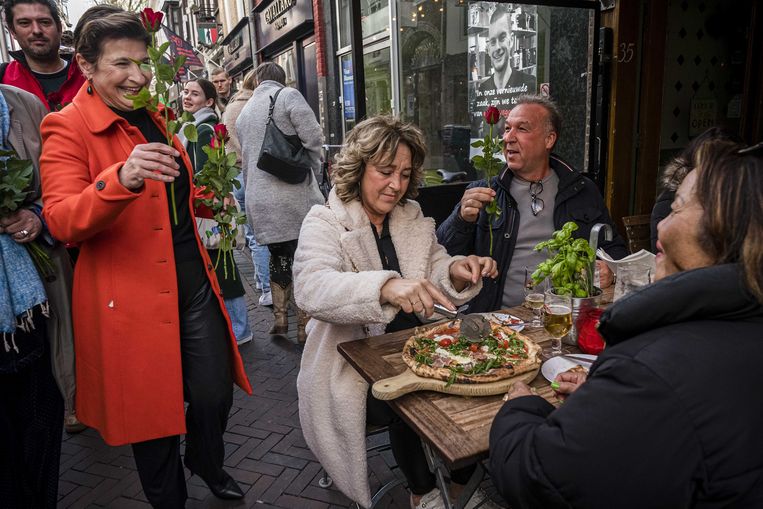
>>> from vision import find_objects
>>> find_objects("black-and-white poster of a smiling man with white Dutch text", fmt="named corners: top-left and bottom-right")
top-left (468, 2), bottom-right (538, 138)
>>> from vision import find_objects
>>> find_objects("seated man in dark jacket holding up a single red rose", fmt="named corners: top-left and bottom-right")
top-left (437, 95), bottom-right (628, 313)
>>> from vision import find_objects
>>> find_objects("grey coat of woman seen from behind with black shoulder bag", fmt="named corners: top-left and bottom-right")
top-left (236, 81), bottom-right (324, 245)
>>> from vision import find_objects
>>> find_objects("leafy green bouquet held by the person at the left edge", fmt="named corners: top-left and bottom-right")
top-left (0, 150), bottom-right (53, 278)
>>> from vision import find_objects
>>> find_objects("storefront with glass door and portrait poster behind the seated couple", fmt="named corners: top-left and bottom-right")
top-left (329, 0), bottom-right (600, 220)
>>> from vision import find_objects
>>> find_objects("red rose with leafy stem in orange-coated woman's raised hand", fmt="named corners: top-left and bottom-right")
top-left (126, 7), bottom-right (196, 225)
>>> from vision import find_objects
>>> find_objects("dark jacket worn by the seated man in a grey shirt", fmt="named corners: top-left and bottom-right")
top-left (437, 154), bottom-right (628, 313)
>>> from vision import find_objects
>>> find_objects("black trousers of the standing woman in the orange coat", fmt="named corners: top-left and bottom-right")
top-left (132, 260), bottom-right (233, 509)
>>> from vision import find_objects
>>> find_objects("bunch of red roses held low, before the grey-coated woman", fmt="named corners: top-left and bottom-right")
top-left (194, 124), bottom-right (246, 279)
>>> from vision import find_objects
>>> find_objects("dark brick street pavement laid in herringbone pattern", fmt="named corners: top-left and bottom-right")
top-left (58, 252), bottom-right (502, 509)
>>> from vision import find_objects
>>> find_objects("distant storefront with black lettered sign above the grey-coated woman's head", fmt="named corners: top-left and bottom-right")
top-left (253, 0), bottom-right (319, 118)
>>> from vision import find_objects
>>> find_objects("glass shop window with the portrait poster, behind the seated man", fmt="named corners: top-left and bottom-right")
top-left (396, 0), bottom-right (594, 181)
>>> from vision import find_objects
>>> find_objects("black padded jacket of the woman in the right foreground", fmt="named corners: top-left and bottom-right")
top-left (490, 264), bottom-right (763, 509)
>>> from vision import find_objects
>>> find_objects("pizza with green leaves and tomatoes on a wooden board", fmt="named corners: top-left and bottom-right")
top-left (403, 320), bottom-right (541, 385)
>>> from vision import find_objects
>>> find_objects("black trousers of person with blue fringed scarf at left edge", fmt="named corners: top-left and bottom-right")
top-left (0, 318), bottom-right (64, 509)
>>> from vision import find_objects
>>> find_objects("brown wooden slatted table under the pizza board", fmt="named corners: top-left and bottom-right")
top-left (337, 290), bottom-right (612, 507)
